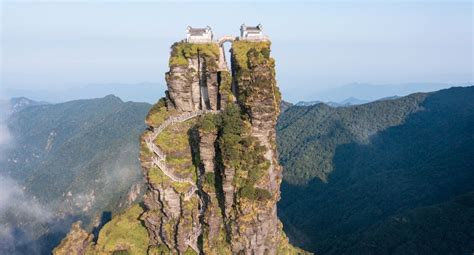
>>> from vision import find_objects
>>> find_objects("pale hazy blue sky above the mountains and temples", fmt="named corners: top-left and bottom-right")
top-left (1, 1), bottom-right (474, 101)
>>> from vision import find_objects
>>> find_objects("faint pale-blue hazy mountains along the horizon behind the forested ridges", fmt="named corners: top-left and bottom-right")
top-left (3, 82), bottom-right (473, 107)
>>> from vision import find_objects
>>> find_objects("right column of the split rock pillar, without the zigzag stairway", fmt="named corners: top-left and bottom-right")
top-left (224, 41), bottom-right (282, 254)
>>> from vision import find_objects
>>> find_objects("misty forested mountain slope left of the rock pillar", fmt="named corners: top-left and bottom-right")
top-left (0, 96), bottom-right (150, 254)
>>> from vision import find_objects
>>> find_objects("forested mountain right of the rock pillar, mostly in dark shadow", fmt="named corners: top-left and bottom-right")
top-left (277, 87), bottom-right (474, 254)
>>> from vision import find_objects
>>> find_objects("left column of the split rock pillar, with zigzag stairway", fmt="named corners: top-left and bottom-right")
top-left (141, 43), bottom-right (224, 252)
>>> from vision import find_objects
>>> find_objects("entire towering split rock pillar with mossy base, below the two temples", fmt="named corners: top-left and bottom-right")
top-left (54, 29), bottom-right (305, 254)
